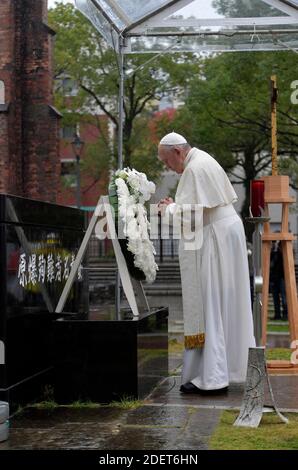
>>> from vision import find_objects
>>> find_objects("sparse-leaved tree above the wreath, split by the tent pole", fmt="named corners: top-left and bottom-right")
top-left (49, 4), bottom-right (198, 182)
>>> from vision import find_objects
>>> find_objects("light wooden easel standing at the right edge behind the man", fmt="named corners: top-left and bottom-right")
top-left (262, 76), bottom-right (298, 373)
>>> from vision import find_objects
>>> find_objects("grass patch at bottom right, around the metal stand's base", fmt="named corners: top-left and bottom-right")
top-left (209, 411), bottom-right (298, 450)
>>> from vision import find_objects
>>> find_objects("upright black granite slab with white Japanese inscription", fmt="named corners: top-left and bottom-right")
top-left (0, 194), bottom-right (88, 403)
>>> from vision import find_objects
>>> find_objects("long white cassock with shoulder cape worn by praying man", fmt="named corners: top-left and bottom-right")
top-left (168, 148), bottom-right (255, 390)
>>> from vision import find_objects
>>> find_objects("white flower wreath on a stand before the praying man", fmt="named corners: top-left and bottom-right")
top-left (113, 168), bottom-right (158, 283)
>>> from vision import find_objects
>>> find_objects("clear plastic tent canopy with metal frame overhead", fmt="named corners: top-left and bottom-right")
top-left (75, 0), bottom-right (298, 54)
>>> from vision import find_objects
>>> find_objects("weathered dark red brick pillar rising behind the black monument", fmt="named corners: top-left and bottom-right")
top-left (0, 0), bottom-right (60, 202)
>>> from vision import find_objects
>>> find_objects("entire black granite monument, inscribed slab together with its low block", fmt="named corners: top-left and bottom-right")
top-left (0, 194), bottom-right (168, 405)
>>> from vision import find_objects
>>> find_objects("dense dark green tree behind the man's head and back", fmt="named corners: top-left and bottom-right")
top-left (170, 52), bottom-right (298, 228)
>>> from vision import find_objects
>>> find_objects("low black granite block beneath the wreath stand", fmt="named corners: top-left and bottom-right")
top-left (54, 307), bottom-right (168, 403)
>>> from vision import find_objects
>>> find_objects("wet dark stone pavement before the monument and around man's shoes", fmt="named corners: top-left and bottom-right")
top-left (0, 346), bottom-right (298, 450)
